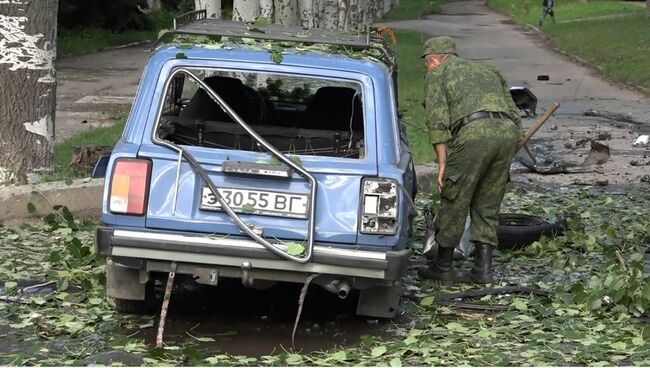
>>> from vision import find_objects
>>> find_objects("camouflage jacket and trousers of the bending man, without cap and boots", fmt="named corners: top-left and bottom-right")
top-left (425, 51), bottom-right (521, 248)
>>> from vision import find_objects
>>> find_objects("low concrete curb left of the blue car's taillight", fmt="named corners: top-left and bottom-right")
top-left (0, 178), bottom-right (104, 223)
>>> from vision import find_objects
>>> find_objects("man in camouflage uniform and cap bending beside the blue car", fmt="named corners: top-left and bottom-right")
top-left (418, 36), bottom-right (521, 284)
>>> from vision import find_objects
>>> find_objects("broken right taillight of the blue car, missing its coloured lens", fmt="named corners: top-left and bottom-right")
top-left (359, 178), bottom-right (398, 235)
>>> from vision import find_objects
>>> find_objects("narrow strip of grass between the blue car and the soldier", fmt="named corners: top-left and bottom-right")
top-left (395, 30), bottom-right (435, 164)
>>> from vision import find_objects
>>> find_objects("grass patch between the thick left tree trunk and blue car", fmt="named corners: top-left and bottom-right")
top-left (42, 117), bottom-right (126, 181)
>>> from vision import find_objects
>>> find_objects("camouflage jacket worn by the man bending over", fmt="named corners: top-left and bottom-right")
top-left (425, 57), bottom-right (521, 144)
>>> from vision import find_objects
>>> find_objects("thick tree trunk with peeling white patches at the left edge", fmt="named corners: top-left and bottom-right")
top-left (0, 0), bottom-right (58, 185)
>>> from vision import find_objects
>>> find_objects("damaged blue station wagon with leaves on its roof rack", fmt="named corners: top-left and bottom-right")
top-left (95, 12), bottom-right (416, 318)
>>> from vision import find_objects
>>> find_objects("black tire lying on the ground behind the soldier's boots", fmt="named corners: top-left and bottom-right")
top-left (497, 213), bottom-right (564, 249)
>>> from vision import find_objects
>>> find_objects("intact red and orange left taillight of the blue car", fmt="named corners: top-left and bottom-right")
top-left (108, 158), bottom-right (151, 216)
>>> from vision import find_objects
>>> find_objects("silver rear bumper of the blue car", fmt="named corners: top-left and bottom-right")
top-left (95, 227), bottom-right (411, 281)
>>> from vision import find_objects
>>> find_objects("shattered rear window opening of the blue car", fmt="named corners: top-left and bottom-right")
top-left (156, 69), bottom-right (365, 159)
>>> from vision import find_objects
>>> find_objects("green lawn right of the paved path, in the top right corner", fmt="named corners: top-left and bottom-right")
top-left (488, 0), bottom-right (650, 90)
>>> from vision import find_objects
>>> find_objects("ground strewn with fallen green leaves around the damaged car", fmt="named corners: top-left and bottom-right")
top-left (0, 186), bottom-right (650, 366)
